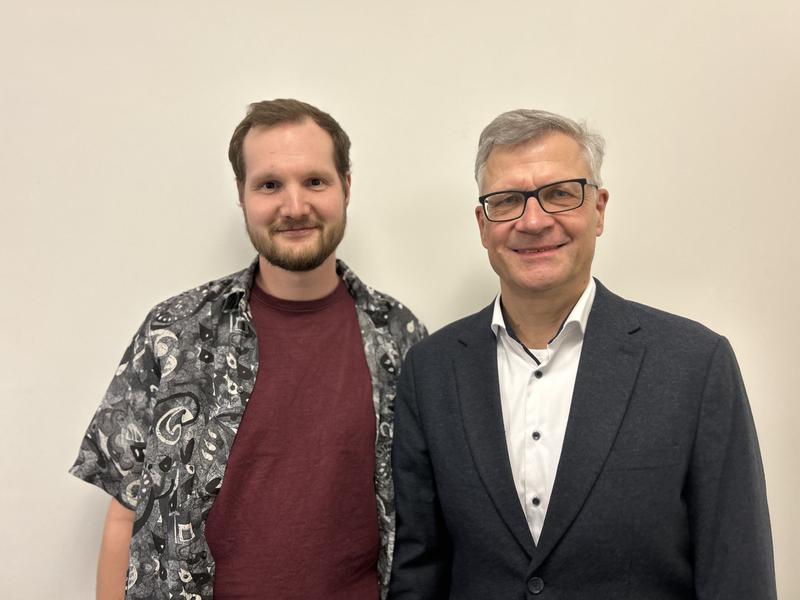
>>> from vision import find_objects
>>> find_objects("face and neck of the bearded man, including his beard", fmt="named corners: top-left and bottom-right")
top-left (240, 119), bottom-right (350, 300)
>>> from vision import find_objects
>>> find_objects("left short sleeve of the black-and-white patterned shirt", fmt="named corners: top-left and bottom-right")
top-left (70, 319), bottom-right (159, 510)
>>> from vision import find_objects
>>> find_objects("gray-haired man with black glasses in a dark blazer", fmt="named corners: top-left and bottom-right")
top-left (390, 110), bottom-right (776, 600)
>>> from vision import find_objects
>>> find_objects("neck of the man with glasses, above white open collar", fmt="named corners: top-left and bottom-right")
top-left (500, 279), bottom-right (589, 349)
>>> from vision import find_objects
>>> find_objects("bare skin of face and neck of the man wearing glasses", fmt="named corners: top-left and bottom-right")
top-left (475, 133), bottom-right (608, 348)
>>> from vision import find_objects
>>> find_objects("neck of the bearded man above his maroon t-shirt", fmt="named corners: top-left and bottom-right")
top-left (256, 254), bottom-right (339, 300)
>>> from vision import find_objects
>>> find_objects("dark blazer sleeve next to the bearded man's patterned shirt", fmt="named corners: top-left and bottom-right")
top-left (388, 348), bottom-right (452, 600)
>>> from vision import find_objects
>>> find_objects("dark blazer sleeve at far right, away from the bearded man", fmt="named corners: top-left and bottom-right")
top-left (687, 338), bottom-right (777, 600)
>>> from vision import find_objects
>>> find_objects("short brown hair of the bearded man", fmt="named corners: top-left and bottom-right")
top-left (228, 98), bottom-right (350, 192)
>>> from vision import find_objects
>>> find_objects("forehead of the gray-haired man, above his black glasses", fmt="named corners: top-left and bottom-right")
top-left (481, 132), bottom-right (589, 192)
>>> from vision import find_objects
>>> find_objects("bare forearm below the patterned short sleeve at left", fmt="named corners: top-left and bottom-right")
top-left (97, 498), bottom-right (134, 600)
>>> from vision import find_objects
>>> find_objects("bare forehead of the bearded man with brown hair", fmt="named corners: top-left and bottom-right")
top-left (242, 119), bottom-right (336, 177)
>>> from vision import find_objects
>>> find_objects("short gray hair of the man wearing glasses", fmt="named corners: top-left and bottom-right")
top-left (475, 108), bottom-right (605, 186)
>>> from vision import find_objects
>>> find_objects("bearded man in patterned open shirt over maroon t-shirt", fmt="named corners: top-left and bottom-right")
top-left (71, 100), bottom-right (425, 600)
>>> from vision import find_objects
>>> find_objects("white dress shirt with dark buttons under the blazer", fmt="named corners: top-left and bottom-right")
top-left (492, 278), bottom-right (596, 544)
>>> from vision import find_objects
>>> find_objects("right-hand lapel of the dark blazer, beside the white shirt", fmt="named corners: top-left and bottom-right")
top-left (531, 282), bottom-right (644, 569)
